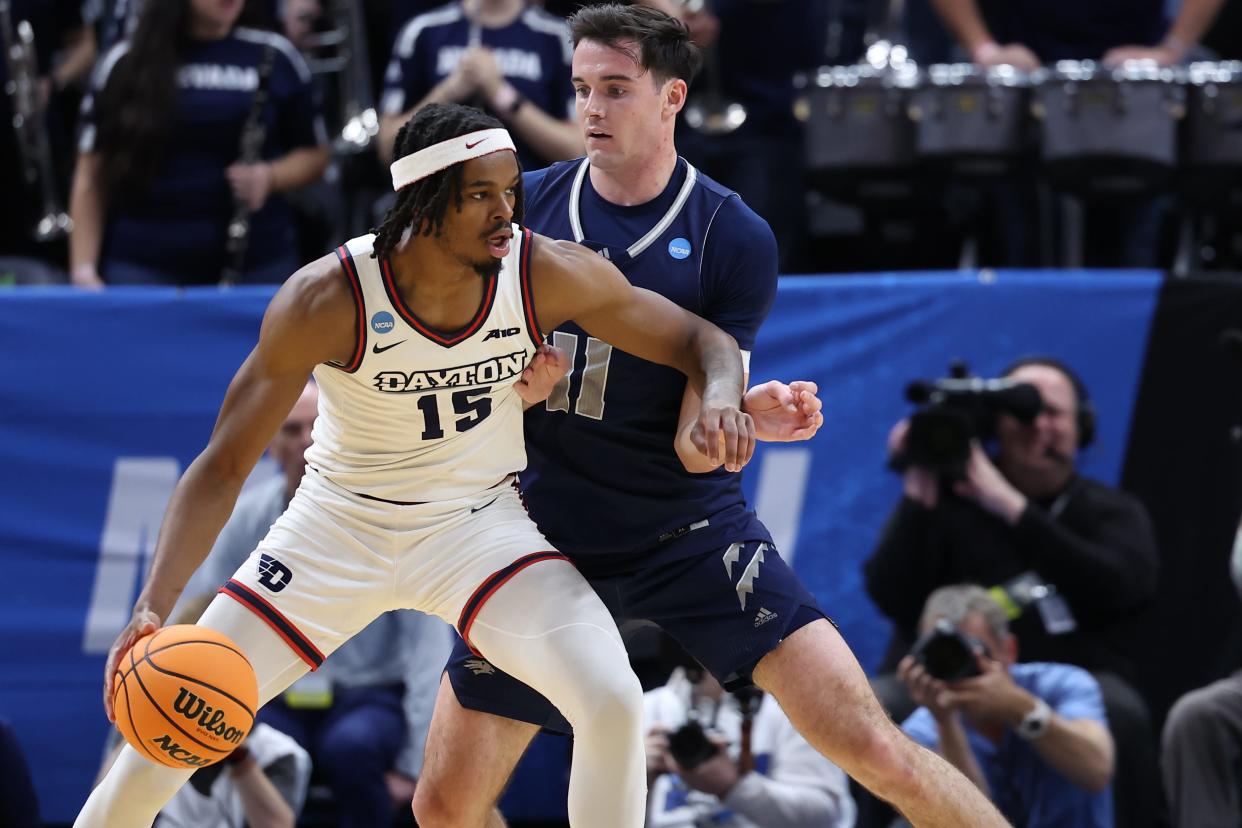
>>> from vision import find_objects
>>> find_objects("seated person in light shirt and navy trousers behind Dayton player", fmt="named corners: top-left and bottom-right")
top-left (186, 382), bottom-right (453, 828)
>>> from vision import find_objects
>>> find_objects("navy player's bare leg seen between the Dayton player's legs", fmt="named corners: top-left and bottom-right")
top-left (414, 675), bottom-right (539, 828)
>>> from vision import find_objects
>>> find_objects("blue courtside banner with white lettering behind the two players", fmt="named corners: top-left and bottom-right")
top-left (0, 272), bottom-right (1160, 822)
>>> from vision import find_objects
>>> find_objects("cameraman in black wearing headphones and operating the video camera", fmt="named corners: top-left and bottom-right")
top-left (864, 358), bottom-right (1159, 826)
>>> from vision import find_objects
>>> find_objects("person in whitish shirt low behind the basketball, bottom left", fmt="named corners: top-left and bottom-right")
top-left (95, 592), bottom-right (311, 828)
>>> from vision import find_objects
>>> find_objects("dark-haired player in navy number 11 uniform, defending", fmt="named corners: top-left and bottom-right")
top-left (414, 5), bottom-right (1005, 828)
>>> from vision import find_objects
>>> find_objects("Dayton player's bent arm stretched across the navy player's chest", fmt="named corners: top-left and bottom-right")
top-left (532, 236), bottom-right (754, 470)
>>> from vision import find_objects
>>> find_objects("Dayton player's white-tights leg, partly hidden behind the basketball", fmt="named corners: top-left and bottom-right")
top-left (73, 596), bottom-right (308, 828)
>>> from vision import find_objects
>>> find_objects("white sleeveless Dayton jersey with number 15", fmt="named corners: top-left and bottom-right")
top-left (307, 225), bottom-right (543, 503)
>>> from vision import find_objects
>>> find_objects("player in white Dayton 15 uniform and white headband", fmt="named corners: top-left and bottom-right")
top-left (76, 104), bottom-right (754, 828)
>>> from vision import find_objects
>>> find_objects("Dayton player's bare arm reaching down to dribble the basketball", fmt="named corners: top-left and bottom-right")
top-left (103, 256), bottom-right (356, 721)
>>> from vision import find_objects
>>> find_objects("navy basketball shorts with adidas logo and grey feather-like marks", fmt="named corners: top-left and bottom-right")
top-left (446, 540), bottom-right (827, 732)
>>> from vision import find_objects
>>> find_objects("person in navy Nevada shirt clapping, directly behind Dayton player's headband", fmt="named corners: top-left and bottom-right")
top-left (379, 0), bottom-right (582, 170)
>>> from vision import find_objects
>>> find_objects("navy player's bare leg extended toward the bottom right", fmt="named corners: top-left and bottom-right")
top-left (754, 618), bottom-right (1009, 828)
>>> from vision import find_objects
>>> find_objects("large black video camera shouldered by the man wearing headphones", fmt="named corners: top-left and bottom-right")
top-left (889, 362), bottom-right (1043, 479)
